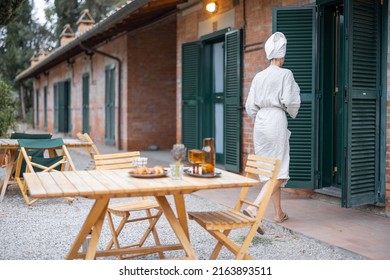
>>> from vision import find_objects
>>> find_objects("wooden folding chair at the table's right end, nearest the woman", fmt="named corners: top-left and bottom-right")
top-left (188, 155), bottom-right (280, 259)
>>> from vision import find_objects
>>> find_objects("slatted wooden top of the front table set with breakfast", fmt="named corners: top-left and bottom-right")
top-left (24, 169), bottom-right (259, 199)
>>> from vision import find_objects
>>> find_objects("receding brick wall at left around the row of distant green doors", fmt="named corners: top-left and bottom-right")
top-left (34, 36), bottom-right (127, 147)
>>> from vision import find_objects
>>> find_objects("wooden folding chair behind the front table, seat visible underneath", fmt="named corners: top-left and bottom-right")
top-left (94, 152), bottom-right (165, 259)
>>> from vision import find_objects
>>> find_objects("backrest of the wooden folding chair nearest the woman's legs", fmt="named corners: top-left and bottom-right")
top-left (234, 155), bottom-right (280, 216)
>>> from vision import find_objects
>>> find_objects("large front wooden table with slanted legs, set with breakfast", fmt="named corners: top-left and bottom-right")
top-left (24, 170), bottom-right (258, 259)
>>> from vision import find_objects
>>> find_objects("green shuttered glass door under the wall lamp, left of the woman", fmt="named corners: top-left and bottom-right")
top-left (182, 30), bottom-right (242, 172)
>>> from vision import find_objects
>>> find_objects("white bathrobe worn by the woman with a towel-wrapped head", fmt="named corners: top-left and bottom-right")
top-left (245, 65), bottom-right (301, 182)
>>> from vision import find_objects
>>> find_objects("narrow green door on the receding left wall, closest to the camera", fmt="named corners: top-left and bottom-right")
top-left (105, 65), bottom-right (115, 145)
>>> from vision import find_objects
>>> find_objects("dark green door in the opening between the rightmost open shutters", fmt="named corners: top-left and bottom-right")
top-left (318, 1), bottom-right (346, 190)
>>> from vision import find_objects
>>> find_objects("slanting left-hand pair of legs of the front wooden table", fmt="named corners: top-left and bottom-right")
top-left (66, 198), bottom-right (110, 260)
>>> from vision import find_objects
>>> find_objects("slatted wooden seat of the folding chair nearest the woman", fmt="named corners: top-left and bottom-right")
top-left (188, 209), bottom-right (255, 230)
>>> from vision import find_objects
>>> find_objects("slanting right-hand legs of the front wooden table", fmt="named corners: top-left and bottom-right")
top-left (156, 196), bottom-right (197, 260)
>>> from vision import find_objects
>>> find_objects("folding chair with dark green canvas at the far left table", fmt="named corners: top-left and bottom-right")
top-left (15, 138), bottom-right (76, 206)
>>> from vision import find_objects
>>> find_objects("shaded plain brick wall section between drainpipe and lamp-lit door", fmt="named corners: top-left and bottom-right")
top-left (127, 16), bottom-right (176, 150)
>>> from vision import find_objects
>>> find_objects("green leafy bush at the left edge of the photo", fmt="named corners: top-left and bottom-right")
top-left (0, 80), bottom-right (16, 137)
